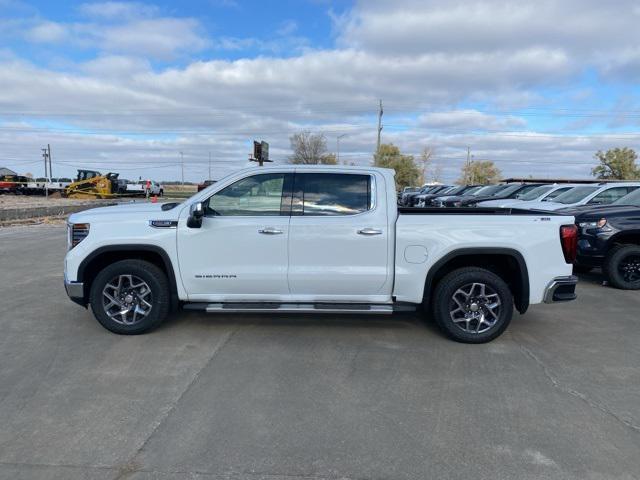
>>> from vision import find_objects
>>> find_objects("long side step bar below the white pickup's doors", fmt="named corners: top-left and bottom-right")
top-left (184, 302), bottom-right (415, 315)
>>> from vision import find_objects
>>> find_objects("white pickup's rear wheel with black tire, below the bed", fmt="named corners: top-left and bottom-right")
top-left (431, 267), bottom-right (513, 343)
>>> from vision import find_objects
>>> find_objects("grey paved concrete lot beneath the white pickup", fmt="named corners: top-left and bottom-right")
top-left (0, 225), bottom-right (640, 480)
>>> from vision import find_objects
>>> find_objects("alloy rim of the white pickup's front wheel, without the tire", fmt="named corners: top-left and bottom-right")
top-left (102, 275), bottom-right (153, 325)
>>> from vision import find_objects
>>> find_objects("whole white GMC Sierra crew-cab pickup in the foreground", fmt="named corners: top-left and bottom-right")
top-left (64, 165), bottom-right (577, 343)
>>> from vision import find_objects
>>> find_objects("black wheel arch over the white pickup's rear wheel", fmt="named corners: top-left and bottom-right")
top-left (423, 247), bottom-right (530, 313)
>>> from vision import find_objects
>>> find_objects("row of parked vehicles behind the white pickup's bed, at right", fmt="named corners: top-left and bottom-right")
top-left (399, 182), bottom-right (640, 290)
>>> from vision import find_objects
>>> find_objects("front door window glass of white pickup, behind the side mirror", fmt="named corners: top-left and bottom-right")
top-left (205, 173), bottom-right (285, 216)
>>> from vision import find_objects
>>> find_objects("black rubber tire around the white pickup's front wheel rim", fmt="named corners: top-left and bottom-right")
top-left (89, 260), bottom-right (171, 335)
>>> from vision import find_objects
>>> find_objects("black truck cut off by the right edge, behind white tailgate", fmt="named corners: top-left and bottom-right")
top-left (557, 189), bottom-right (640, 290)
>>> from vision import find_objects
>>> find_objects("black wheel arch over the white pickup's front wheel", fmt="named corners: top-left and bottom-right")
top-left (77, 244), bottom-right (179, 310)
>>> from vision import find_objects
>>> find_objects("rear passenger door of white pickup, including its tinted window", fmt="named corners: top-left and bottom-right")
top-left (288, 172), bottom-right (392, 302)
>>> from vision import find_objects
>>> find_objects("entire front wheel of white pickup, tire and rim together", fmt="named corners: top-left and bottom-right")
top-left (90, 260), bottom-right (170, 335)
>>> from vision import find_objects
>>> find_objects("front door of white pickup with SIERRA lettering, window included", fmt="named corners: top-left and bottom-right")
top-left (178, 173), bottom-right (293, 301)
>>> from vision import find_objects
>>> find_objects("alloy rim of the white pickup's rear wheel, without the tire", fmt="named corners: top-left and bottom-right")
top-left (449, 283), bottom-right (502, 334)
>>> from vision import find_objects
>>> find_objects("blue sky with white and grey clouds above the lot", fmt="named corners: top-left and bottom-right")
top-left (0, 0), bottom-right (640, 181)
